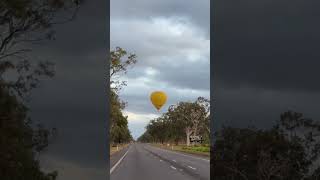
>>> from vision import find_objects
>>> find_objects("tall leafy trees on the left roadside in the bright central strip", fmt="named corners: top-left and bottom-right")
top-left (109, 47), bottom-right (137, 144)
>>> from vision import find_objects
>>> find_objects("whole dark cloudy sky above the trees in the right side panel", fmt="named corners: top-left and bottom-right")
top-left (213, 0), bottom-right (320, 127)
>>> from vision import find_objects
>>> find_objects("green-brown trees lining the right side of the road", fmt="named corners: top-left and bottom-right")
top-left (138, 97), bottom-right (210, 146)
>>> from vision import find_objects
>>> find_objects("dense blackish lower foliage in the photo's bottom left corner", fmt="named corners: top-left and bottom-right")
top-left (0, 88), bottom-right (57, 180)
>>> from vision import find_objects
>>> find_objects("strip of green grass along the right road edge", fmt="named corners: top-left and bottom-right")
top-left (152, 143), bottom-right (210, 157)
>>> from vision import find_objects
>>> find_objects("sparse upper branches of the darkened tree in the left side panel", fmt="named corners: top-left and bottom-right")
top-left (0, 0), bottom-right (80, 98)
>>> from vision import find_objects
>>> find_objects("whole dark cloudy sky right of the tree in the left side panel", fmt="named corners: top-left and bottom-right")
top-left (30, 0), bottom-right (108, 180)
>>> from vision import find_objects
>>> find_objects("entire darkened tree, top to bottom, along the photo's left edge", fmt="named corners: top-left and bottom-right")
top-left (0, 0), bottom-right (80, 180)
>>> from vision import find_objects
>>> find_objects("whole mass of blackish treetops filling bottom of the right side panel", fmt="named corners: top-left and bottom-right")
top-left (210, 111), bottom-right (320, 180)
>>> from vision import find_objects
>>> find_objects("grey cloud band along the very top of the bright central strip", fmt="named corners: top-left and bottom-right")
top-left (110, 0), bottom-right (210, 36)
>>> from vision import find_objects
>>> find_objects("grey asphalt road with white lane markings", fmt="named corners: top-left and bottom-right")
top-left (110, 143), bottom-right (210, 180)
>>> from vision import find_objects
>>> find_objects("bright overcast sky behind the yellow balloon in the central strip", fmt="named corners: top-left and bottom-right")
top-left (110, 0), bottom-right (210, 138)
